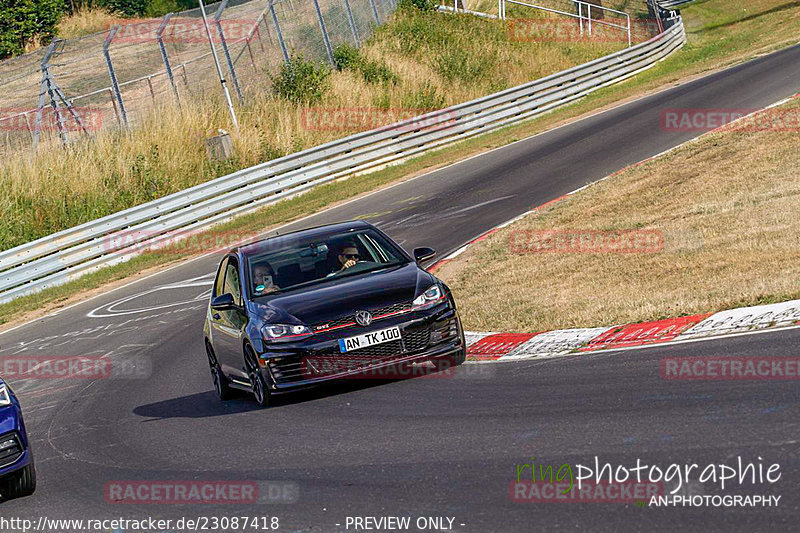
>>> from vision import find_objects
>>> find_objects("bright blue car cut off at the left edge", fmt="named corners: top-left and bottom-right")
top-left (0, 379), bottom-right (36, 500)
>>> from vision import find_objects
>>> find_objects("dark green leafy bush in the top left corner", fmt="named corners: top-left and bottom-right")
top-left (0, 0), bottom-right (64, 59)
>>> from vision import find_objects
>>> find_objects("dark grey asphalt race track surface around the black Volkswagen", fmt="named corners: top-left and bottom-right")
top-left (0, 46), bottom-right (800, 532)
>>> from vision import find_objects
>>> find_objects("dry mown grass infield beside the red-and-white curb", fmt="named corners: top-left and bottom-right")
top-left (440, 93), bottom-right (800, 331)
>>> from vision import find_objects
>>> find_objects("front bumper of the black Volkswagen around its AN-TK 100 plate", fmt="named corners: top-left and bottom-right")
top-left (259, 303), bottom-right (465, 393)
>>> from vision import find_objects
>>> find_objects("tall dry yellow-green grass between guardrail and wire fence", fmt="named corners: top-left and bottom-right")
top-left (0, 7), bottom-right (623, 249)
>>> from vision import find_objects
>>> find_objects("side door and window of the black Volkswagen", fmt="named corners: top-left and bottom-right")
top-left (211, 255), bottom-right (247, 378)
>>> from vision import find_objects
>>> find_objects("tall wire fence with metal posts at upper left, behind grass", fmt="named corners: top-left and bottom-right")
top-left (0, 0), bottom-right (397, 151)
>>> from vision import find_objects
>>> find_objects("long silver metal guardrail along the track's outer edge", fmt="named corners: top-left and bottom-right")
top-left (0, 18), bottom-right (686, 303)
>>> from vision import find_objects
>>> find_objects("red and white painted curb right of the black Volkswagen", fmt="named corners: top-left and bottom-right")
top-left (465, 300), bottom-right (800, 362)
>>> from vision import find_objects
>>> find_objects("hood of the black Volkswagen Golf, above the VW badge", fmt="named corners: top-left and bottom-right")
top-left (250, 263), bottom-right (434, 325)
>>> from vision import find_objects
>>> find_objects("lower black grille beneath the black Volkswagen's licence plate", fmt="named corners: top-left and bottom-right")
top-left (267, 327), bottom-right (431, 385)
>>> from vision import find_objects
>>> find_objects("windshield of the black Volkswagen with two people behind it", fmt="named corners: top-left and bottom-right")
top-left (247, 228), bottom-right (408, 297)
